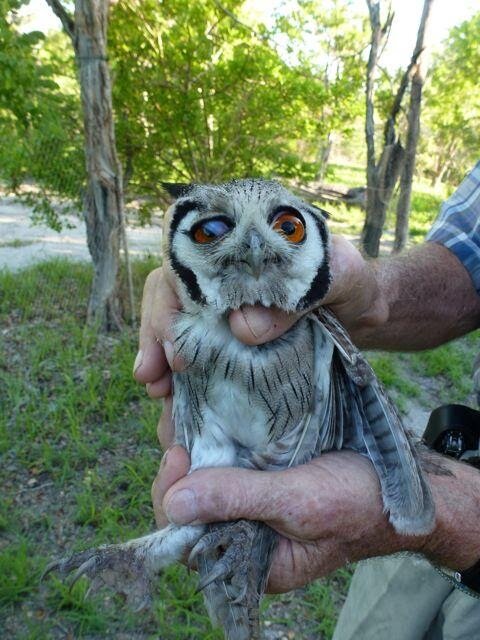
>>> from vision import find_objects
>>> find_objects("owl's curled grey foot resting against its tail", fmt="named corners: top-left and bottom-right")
top-left (188, 520), bottom-right (256, 604)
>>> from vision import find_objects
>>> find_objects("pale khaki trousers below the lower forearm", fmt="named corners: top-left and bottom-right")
top-left (333, 556), bottom-right (480, 640)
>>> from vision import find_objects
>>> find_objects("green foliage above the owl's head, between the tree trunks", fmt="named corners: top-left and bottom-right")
top-left (109, 0), bottom-right (360, 208)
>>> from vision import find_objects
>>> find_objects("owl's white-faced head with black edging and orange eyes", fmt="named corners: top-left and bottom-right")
top-left (164, 179), bottom-right (331, 313)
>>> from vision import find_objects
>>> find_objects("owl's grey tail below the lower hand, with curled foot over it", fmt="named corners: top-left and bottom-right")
top-left (192, 520), bottom-right (278, 640)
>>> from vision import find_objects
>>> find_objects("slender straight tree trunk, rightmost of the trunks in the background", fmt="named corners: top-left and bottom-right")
top-left (393, 0), bottom-right (434, 253)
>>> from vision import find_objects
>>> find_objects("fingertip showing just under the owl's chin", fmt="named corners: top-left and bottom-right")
top-left (229, 306), bottom-right (300, 345)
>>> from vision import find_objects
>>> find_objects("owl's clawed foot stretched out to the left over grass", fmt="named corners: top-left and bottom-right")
top-left (42, 543), bottom-right (152, 612)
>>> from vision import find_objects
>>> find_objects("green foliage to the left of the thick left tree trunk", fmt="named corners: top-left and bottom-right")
top-left (0, 0), bottom-right (84, 229)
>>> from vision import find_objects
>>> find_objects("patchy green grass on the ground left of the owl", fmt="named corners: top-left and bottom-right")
top-left (0, 260), bottom-right (227, 640)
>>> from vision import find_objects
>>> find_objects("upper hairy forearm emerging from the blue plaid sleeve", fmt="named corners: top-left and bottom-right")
top-left (347, 243), bottom-right (480, 350)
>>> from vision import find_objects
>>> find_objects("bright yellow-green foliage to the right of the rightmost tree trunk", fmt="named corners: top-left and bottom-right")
top-left (421, 12), bottom-right (480, 183)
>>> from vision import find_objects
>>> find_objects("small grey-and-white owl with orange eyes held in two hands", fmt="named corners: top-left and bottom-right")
top-left (48, 179), bottom-right (434, 640)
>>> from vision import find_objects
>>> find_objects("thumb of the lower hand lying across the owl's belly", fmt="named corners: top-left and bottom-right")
top-left (163, 468), bottom-right (282, 524)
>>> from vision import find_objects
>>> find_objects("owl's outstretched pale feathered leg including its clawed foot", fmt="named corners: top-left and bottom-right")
top-left (43, 525), bottom-right (204, 611)
